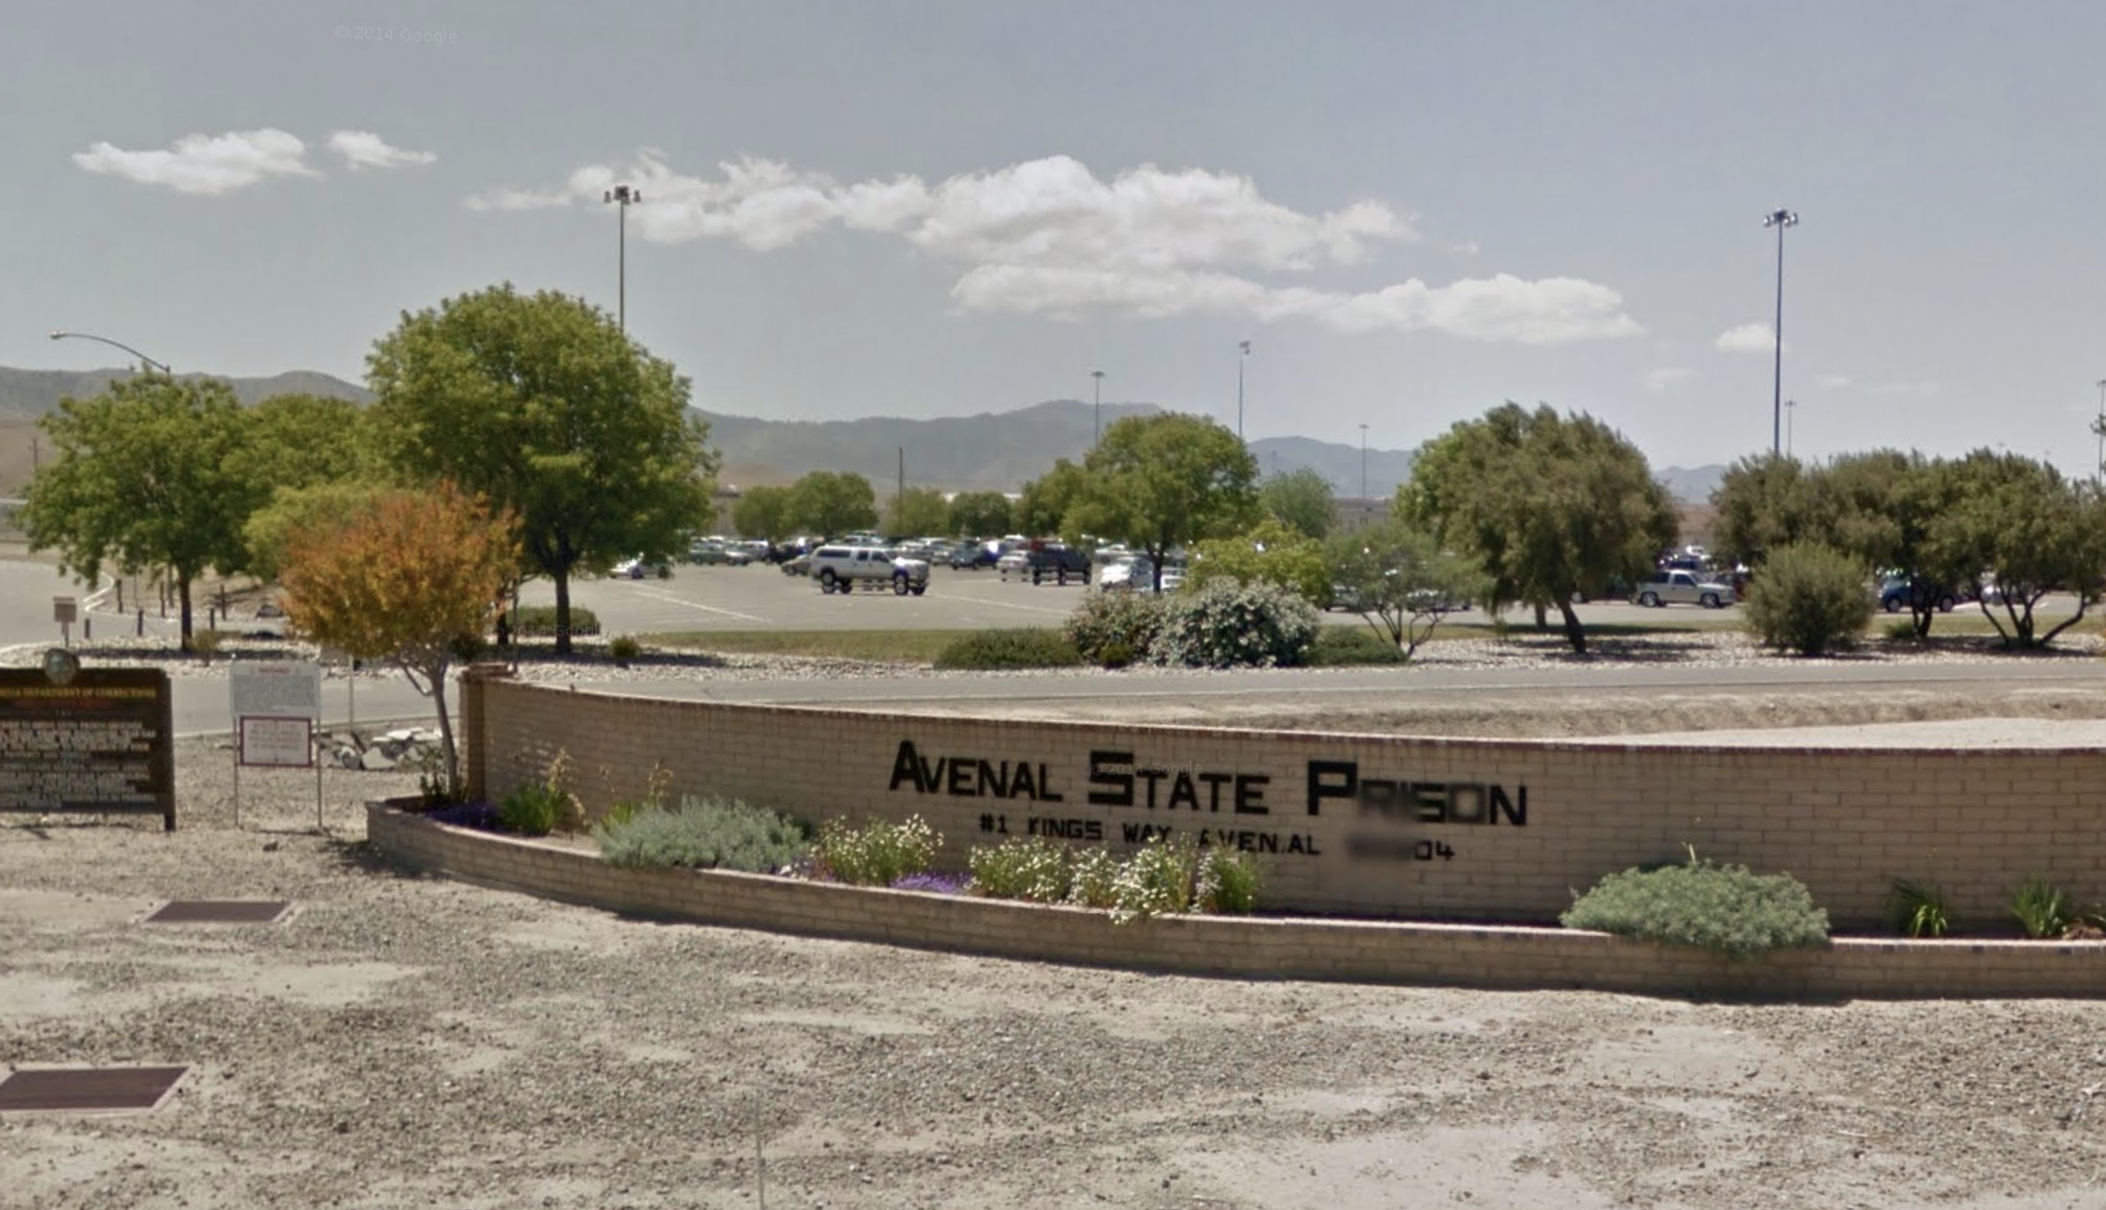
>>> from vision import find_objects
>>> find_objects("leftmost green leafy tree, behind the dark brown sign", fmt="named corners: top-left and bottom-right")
top-left (21, 375), bottom-right (261, 652)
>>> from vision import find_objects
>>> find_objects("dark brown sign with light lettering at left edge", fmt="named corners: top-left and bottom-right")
top-left (0, 661), bottom-right (175, 831)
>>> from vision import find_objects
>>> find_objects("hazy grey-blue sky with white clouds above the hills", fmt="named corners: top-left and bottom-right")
top-left (16, 0), bottom-right (2106, 473)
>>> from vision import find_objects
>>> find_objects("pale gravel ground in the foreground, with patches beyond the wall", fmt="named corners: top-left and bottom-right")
top-left (0, 639), bottom-right (2106, 1210)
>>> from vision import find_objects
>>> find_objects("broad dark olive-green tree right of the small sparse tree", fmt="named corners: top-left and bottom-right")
top-left (1398, 404), bottom-right (1678, 654)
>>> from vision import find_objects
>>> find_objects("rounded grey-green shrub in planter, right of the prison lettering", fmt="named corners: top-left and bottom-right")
top-left (1558, 854), bottom-right (1828, 960)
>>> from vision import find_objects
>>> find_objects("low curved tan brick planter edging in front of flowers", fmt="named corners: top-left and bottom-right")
top-left (366, 804), bottom-right (2106, 997)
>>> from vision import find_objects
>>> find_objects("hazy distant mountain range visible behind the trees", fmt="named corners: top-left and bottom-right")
top-left (0, 366), bottom-right (1725, 501)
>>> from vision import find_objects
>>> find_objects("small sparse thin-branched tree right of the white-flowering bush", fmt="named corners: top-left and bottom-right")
top-left (1329, 516), bottom-right (1491, 659)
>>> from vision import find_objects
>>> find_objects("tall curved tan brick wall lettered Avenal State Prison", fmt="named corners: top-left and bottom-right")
top-left (463, 680), bottom-right (2106, 930)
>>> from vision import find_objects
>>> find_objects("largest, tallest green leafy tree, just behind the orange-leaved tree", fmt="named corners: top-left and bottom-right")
top-left (366, 284), bottom-right (718, 654)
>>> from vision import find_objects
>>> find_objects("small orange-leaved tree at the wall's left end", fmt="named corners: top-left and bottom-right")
top-left (280, 484), bottom-right (520, 795)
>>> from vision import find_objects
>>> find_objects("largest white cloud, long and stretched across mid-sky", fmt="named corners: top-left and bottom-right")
top-left (470, 152), bottom-right (1643, 343)
